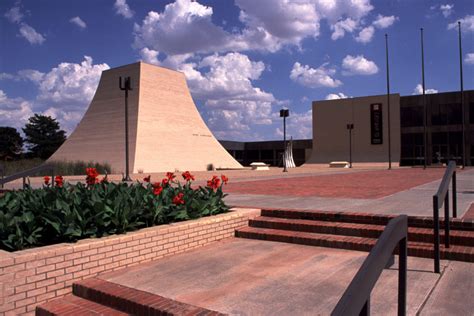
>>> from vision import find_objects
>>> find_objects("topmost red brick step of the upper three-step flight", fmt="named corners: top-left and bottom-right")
top-left (261, 209), bottom-right (474, 231)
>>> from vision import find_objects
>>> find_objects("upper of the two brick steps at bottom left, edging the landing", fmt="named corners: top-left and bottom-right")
top-left (72, 278), bottom-right (222, 316)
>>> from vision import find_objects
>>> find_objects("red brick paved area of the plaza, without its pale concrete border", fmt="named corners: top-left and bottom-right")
top-left (225, 168), bottom-right (445, 199)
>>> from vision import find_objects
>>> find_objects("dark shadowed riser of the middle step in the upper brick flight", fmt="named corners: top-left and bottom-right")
top-left (249, 220), bottom-right (474, 247)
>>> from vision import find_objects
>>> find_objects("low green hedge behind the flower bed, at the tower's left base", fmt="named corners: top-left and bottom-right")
top-left (0, 158), bottom-right (112, 176)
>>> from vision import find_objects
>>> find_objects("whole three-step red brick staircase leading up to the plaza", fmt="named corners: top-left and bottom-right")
top-left (235, 210), bottom-right (474, 262)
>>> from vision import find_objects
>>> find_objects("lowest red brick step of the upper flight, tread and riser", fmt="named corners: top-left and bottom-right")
top-left (235, 227), bottom-right (474, 262)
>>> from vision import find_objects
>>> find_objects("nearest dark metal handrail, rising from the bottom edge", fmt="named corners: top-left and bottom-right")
top-left (331, 215), bottom-right (408, 316)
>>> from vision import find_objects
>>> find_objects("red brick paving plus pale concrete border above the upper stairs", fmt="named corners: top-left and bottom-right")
top-left (226, 169), bottom-right (474, 217)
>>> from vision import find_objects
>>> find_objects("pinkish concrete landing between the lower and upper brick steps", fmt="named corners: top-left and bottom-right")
top-left (100, 238), bottom-right (454, 315)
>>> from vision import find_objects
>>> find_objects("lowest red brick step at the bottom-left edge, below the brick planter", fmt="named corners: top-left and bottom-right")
top-left (36, 295), bottom-right (128, 316)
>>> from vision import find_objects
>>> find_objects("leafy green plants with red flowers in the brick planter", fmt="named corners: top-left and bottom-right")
top-left (0, 169), bottom-right (229, 251)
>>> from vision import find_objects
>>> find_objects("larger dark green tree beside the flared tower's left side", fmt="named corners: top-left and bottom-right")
top-left (23, 114), bottom-right (66, 159)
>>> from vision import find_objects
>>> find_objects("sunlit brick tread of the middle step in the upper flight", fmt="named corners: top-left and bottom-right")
top-left (250, 216), bottom-right (474, 239)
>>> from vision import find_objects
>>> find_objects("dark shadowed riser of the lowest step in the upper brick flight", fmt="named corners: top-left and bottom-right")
top-left (235, 230), bottom-right (474, 262)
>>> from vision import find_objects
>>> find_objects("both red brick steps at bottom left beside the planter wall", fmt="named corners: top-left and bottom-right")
top-left (36, 278), bottom-right (223, 316)
